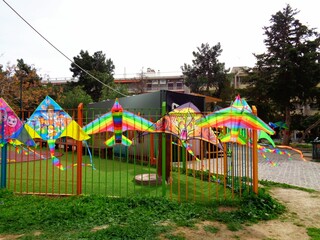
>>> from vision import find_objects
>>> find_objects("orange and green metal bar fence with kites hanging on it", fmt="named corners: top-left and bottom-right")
top-left (0, 104), bottom-right (258, 201)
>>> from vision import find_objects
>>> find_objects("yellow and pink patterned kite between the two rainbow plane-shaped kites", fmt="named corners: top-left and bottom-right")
top-left (155, 102), bottom-right (222, 160)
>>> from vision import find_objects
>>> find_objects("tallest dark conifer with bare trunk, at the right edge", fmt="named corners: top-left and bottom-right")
top-left (242, 5), bottom-right (320, 145)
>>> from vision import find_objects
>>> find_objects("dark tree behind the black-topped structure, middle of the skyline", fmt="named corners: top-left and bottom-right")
top-left (181, 43), bottom-right (227, 97)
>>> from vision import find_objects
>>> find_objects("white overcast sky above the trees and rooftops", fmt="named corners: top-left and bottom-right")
top-left (0, 0), bottom-right (320, 78)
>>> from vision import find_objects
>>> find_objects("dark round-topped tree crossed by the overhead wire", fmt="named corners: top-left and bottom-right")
top-left (68, 50), bottom-right (115, 101)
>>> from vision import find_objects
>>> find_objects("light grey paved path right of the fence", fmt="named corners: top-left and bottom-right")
top-left (258, 151), bottom-right (320, 191)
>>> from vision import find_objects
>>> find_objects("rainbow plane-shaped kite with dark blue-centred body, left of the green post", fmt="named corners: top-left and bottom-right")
top-left (83, 98), bottom-right (154, 147)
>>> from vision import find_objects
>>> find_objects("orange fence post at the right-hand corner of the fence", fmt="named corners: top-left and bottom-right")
top-left (252, 106), bottom-right (258, 194)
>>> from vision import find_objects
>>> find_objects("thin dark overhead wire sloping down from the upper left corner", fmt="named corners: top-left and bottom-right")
top-left (3, 0), bottom-right (127, 97)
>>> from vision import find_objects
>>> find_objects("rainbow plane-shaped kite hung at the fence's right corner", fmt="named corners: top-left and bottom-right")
top-left (196, 95), bottom-right (275, 145)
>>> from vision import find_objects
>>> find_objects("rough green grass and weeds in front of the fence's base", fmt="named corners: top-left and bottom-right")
top-left (0, 189), bottom-right (283, 239)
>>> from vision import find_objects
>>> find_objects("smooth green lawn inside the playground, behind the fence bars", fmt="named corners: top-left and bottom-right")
top-left (7, 153), bottom-right (237, 201)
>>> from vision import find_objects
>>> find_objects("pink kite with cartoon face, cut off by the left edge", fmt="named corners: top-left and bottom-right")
top-left (0, 98), bottom-right (35, 146)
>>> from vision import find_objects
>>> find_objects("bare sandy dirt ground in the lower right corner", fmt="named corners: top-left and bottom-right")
top-left (162, 188), bottom-right (320, 240)
